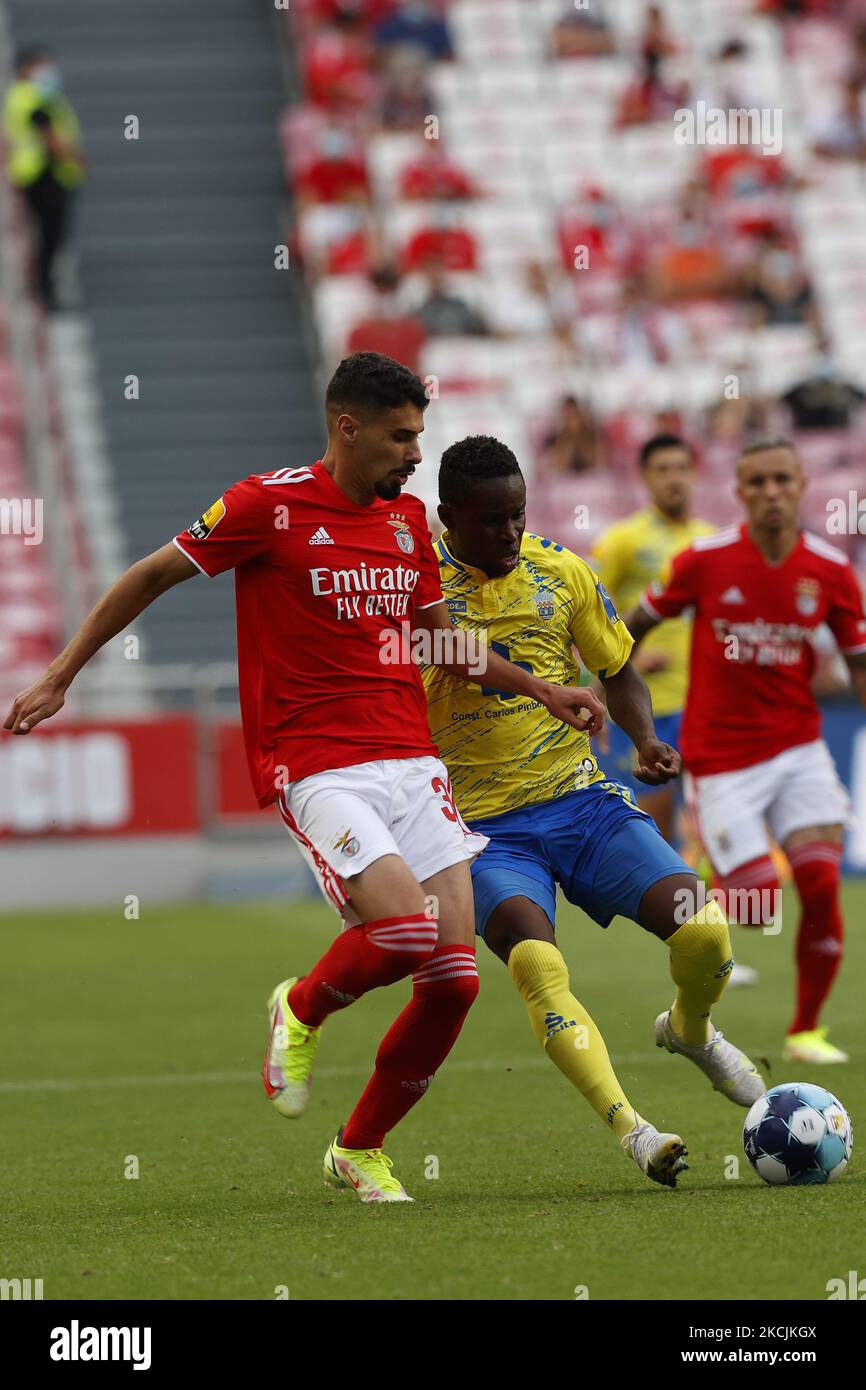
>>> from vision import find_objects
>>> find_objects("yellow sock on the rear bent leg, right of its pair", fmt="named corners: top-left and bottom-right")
top-left (666, 899), bottom-right (734, 1047)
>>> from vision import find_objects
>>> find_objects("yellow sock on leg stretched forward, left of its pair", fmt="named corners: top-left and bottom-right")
top-left (509, 927), bottom-right (639, 1140)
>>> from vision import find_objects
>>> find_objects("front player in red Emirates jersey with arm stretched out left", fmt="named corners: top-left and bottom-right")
top-left (4, 353), bottom-right (603, 1202)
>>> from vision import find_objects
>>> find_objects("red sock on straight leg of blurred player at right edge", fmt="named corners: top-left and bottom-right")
top-left (788, 840), bottom-right (844, 1033)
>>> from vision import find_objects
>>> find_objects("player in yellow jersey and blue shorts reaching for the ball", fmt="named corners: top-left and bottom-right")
top-left (424, 436), bottom-right (765, 1187)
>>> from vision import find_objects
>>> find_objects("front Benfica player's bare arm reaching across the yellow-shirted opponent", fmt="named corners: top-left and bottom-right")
top-left (416, 603), bottom-right (605, 734)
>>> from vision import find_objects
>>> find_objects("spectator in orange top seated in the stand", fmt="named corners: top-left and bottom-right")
top-left (648, 183), bottom-right (731, 302)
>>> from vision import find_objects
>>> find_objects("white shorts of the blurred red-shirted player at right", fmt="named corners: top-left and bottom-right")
top-left (687, 738), bottom-right (851, 877)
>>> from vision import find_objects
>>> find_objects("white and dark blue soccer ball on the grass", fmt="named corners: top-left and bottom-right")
top-left (742, 1081), bottom-right (853, 1187)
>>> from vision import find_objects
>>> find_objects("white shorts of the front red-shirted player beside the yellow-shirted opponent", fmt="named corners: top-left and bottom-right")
top-left (277, 758), bottom-right (488, 922)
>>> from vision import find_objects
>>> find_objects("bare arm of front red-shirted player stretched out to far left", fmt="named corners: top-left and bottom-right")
top-left (3, 543), bottom-right (199, 734)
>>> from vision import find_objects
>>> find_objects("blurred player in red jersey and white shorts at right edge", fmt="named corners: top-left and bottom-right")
top-left (626, 439), bottom-right (866, 1063)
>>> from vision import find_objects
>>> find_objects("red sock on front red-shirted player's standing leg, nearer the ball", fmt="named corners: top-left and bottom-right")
top-left (341, 945), bottom-right (478, 1148)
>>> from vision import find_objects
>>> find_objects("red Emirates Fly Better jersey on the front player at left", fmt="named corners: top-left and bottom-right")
top-left (174, 461), bottom-right (442, 806)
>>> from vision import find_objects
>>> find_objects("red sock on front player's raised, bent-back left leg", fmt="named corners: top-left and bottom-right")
top-left (289, 912), bottom-right (439, 1027)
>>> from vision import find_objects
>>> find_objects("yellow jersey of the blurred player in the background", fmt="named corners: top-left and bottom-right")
top-left (592, 506), bottom-right (716, 716)
